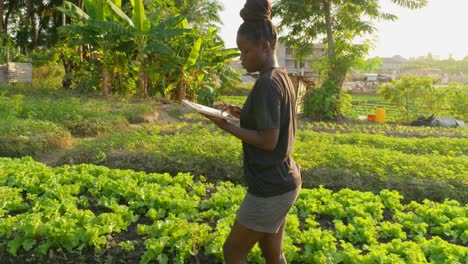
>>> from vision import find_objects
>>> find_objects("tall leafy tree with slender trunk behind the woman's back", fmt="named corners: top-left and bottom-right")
top-left (273, 0), bottom-right (427, 117)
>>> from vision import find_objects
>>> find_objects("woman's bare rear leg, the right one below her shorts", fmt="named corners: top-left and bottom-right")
top-left (258, 221), bottom-right (286, 264)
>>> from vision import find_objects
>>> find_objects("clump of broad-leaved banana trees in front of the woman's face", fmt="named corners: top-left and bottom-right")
top-left (60, 0), bottom-right (238, 100)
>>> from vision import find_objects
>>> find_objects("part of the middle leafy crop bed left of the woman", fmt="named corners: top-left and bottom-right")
top-left (60, 122), bottom-right (242, 182)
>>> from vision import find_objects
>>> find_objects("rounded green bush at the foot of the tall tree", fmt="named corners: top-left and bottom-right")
top-left (303, 80), bottom-right (351, 120)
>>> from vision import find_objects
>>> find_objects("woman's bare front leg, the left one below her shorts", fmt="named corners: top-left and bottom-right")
top-left (223, 220), bottom-right (266, 264)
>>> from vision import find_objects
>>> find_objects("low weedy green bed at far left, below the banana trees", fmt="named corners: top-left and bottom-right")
top-left (0, 88), bottom-right (162, 137)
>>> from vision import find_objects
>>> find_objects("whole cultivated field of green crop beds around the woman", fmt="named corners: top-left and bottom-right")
top-left (0, 84), bottom-right (468, 263)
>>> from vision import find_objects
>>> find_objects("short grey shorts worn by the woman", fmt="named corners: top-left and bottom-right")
top-left (236, 186), bottom-right (301, 234)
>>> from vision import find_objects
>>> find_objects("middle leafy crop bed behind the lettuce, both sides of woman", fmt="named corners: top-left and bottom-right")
top-left (59, 121), bottom-right (468, 202)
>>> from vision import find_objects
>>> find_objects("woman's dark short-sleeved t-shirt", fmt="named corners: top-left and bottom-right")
top-left (240, 68), bottom-right (301, 197)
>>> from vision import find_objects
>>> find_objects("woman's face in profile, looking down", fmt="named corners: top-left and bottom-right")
top-left (237, 34), bottom-right (267, 72)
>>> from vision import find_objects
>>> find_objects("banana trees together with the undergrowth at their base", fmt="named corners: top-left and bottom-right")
top-left (60, 0), bottom-right (239, 99)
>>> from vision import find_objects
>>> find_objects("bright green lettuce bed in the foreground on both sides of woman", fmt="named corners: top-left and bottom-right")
top-left (0, 158), bottom-right (468, 263)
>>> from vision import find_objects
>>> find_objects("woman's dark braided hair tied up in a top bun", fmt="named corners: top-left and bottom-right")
top-left (237, 0), bottom-right (278, 49)
